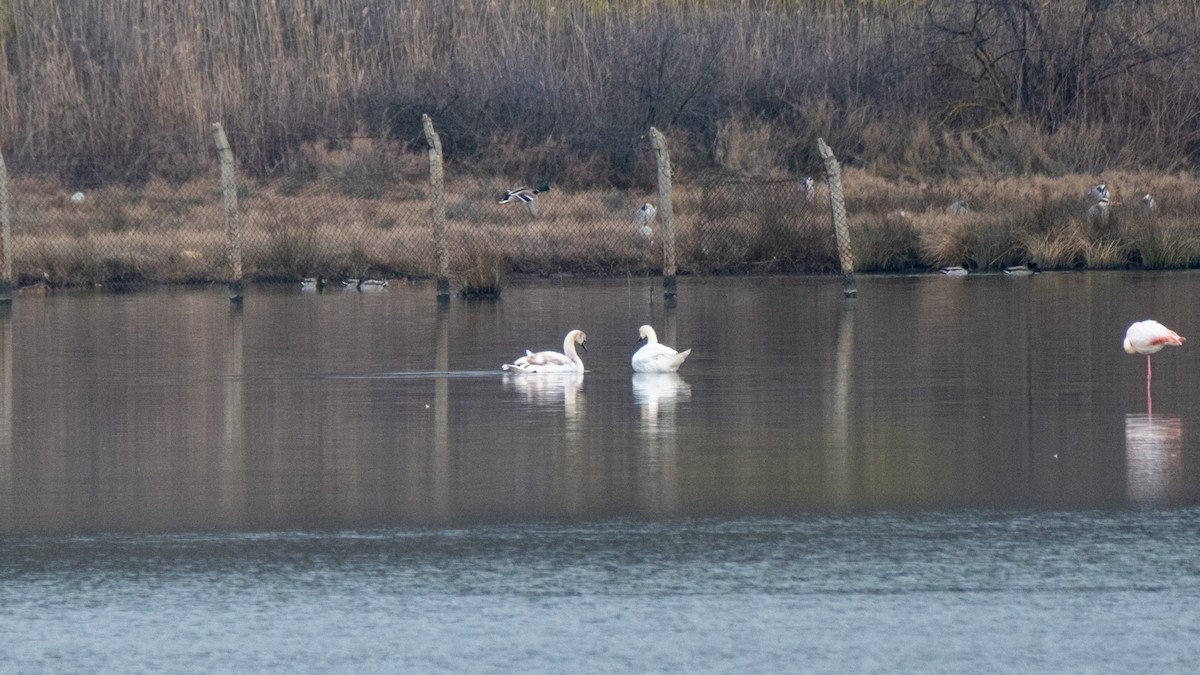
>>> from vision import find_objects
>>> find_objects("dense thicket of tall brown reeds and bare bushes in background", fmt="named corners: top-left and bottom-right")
top-left (0, 0), bottom-right (1200, 187)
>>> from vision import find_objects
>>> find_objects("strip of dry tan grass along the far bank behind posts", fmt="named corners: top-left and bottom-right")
top-left (10, 148), bottom-right (1200, 284)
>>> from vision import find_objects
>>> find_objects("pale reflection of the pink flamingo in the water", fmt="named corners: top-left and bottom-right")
top-left (1126, 414), bottom-right (1183, 503)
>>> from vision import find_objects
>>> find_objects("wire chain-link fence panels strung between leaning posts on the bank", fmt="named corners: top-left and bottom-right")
top-left (0, 139), bottom-right (838, 286)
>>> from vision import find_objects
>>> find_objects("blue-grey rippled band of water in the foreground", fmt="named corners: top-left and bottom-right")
top-left (7, 508), bottom-right (1200, 673)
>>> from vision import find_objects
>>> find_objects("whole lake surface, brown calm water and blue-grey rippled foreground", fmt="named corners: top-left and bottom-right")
top-left (0, 271), bottom-right (1200, 673)
